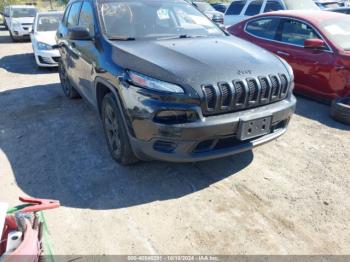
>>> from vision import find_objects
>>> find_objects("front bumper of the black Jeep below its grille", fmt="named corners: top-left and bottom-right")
top-left (123, 87), bottom-right (296, 162)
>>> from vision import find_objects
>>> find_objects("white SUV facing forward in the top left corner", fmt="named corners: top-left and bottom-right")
top-left (4, 5), bottom-right (37, 42)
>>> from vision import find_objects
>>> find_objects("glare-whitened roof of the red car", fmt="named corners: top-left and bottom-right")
top-left (259, 10), bottom-right (348, 24)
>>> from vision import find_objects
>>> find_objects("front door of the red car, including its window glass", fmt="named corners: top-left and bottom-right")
top-left (271, 18), bottom-right (335, 98)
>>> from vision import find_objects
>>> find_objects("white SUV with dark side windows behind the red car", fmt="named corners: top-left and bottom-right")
top-left (224, 0), bottom-right (320, 26)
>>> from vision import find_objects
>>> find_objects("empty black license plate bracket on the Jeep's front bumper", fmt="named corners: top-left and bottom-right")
top-left (237, 116), bottom-right (272, 140)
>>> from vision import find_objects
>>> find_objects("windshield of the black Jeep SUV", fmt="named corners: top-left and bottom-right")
top-left (100, 0), bottom-right (225, 40)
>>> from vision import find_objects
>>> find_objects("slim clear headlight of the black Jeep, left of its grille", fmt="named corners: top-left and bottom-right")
top-left (129, 71), bottom-right (184, 94)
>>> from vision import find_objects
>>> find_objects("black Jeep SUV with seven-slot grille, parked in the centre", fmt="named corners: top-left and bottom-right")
top-left (57, 0), bottom-right (296, 164)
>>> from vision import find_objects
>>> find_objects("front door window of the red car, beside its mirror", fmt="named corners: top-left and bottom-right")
top-left (280, 19), bottom-right (320, 46)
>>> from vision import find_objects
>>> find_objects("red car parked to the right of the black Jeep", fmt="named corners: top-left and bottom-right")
top-left (228, 11), bottom-right (350, 101)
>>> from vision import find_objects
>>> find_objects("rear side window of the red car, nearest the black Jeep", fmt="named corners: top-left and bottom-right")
top-left (246, 18), bottom-right (280, 40)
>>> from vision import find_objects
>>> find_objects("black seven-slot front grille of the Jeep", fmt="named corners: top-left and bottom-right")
top-left (202, 74), bottom-right (290, 116)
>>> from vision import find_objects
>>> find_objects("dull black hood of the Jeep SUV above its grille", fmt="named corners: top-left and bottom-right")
top-left (112, 36), bottom-right (288, 92)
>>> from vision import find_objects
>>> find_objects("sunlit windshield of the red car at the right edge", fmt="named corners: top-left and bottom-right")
top-left (321, 15), bottom-right (350, 51)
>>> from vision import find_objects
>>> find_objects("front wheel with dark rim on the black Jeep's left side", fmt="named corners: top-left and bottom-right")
top-left (101, 93), bottom-right (139, 165)
